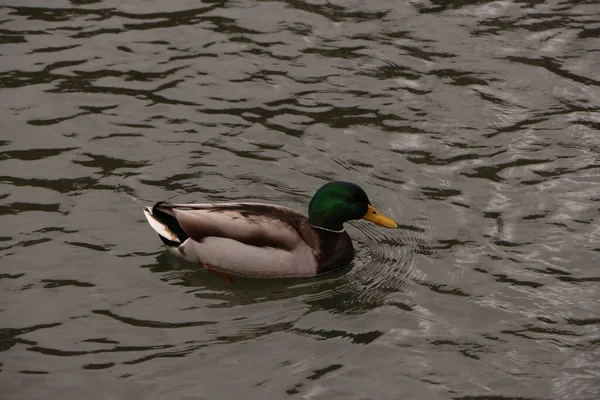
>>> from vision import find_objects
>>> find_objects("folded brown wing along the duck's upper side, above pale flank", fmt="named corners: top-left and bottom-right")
top-left (152, 203), bottom-right (319, 251)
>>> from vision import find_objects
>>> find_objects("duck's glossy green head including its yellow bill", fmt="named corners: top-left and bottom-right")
top-left (308, 181), bottom-right (398, 231)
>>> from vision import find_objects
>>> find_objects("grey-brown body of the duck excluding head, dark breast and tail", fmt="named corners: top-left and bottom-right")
top-left (146, 203), bottom-right (319, 277)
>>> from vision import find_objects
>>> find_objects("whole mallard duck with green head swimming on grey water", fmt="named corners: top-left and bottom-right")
top-left (144, 181), bottom-right (398, 278)
